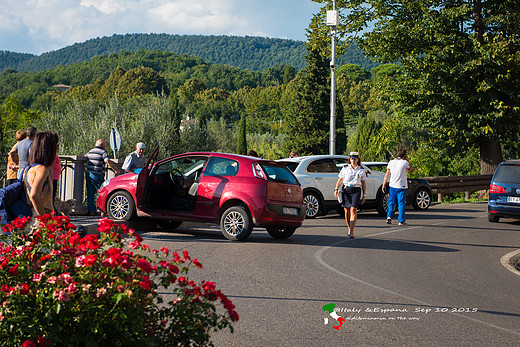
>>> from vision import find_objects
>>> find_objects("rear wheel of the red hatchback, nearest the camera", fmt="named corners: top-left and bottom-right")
top-left (220, 206), bottom-right (253, 241)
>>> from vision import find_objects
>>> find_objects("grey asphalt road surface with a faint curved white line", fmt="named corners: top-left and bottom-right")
top-left (71, 203), bottom-right (520, 346)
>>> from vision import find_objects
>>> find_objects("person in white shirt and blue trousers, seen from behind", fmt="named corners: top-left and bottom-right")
top-left (382, 149), bottom-right (414, 225)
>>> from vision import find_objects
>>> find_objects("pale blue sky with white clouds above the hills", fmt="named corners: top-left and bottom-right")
top-left (0, 0), bottom-right (320, 54)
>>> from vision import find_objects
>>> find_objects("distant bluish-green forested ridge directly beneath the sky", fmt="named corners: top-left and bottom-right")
top-left (0, 34), bottom-right (377, 72)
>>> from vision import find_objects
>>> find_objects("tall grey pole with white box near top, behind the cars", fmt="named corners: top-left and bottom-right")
top-left (327, 0), bottom-right (338, 155)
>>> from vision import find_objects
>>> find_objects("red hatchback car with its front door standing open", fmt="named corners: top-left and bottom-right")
top-left (97, 149), bottom-right (305, 240)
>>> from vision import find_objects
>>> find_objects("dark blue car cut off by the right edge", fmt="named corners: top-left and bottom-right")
top-left (488, 160), bottom-right (520, 222)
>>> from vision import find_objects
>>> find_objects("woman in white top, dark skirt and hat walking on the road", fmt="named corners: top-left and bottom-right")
top-left (334, 152), bottom-right (367, 239)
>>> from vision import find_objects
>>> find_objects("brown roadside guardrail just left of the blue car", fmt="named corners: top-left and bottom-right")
top-left (421, 175), bottom-right (493, 202)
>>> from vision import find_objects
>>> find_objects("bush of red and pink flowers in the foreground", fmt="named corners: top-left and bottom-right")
top-left (0, 215), bottom-right (238, 346)
